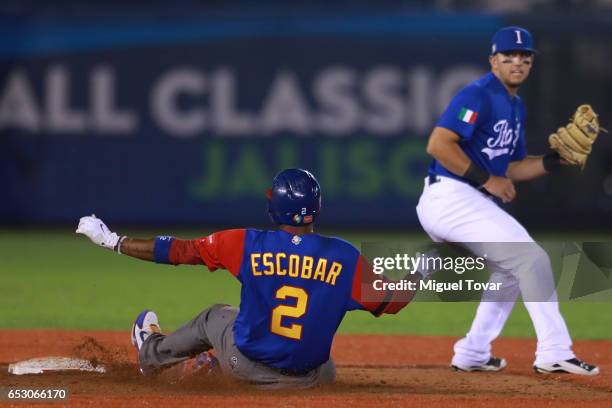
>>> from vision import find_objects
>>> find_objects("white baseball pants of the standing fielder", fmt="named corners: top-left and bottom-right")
top-left (417, 176), bottom-right (574, 366)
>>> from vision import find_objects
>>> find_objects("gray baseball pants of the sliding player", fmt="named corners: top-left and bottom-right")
top-left (138, 304), bottom-right (336, 389)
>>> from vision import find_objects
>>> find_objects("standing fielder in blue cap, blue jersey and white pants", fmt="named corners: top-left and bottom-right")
top-left (417, 27), bottom-right (599, 375)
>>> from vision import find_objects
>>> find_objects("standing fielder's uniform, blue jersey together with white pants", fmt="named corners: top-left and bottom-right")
top-left (417, 73), bottom-right (574, 366)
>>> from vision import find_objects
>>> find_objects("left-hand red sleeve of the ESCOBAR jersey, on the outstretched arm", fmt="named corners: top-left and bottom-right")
top-left (170, 229), bottom-right (246, 276)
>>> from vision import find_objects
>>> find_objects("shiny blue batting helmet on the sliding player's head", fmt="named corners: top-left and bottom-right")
top-left (267, 169), bottom-right (321, 226)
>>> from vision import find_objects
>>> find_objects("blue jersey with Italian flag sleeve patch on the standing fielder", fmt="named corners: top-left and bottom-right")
top-left (429, 72), bottom-right (527, 182)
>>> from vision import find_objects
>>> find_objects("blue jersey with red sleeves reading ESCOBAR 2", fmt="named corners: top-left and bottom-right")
top-left (161, 229), bottom-right (406, 371)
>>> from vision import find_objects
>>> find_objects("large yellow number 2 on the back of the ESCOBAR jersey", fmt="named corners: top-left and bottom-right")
top-left (270, 285), bottom-right (308, 340)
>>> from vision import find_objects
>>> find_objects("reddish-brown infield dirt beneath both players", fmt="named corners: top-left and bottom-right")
top-left (0, 330), bottom-right (612, 408)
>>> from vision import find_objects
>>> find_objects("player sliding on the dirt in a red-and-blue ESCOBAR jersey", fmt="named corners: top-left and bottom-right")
top-left (76, 169), bottom-right (407, 388)
